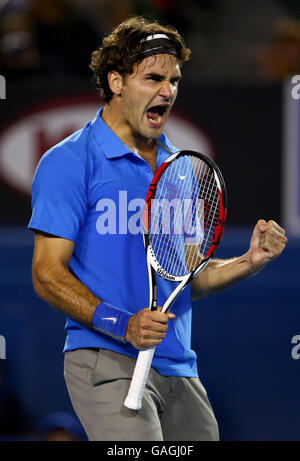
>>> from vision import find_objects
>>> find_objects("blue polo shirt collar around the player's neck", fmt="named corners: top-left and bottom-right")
top-left (91, 107), bottom-right (178, 159)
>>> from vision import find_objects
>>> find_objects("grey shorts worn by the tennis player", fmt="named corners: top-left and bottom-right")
top-left (64, 349), bottom-right (219, 441)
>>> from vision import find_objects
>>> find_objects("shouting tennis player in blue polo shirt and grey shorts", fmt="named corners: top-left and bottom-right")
top-left (29, 13), bottom-right (287, 441)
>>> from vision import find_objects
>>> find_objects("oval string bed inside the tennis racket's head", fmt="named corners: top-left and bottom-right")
top-left (150, 155), bottom-right (219, 276)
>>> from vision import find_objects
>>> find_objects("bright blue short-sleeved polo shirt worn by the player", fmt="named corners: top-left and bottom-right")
top-left (28, 109), bottom-right (197, 377)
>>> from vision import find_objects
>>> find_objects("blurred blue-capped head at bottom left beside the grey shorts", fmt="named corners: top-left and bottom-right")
top-left (37, 412), bottom-right (87, 442)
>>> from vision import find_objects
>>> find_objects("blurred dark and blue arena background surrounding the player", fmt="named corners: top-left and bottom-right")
top-left (0, 0), bottom-right (300, 440)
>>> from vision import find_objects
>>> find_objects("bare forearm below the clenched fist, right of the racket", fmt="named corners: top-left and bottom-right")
top-left (192, 253), bottom-right (263, 299)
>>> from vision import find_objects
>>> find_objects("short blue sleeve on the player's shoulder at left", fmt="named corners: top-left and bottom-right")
top-left (28, 146), bottom-right (87, 241)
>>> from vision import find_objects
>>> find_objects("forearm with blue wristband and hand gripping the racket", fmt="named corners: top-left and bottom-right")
top-left (33, 265), bottom-right (171, 349)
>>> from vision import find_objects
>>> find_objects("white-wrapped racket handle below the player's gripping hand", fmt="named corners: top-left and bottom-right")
top-left (124, 346), bottom-right (155, 410)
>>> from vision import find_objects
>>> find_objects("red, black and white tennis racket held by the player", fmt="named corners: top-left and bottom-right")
top-left (124, 150), bottom-right (227, 410)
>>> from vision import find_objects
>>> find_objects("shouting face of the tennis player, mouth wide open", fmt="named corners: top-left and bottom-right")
top-left (120, 54), bottom-right (181, 139)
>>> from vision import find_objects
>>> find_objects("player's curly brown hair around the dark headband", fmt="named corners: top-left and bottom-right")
top-left (90, 16), bottom-right (191, 103)
